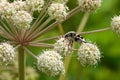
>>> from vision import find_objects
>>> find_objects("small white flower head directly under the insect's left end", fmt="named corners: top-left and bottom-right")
top-left (54, 38), bottom-right (72, 56)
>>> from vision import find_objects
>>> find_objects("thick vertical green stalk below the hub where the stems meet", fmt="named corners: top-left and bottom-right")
top-left (18, 47), bottom-right (26, 80)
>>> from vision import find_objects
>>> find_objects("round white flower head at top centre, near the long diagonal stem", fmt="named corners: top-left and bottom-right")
top-left (48, 3), bottom-right (68, 20)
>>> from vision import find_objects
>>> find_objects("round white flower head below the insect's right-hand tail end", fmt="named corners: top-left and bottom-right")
top-left (78, 43), bottom-right (101, 66)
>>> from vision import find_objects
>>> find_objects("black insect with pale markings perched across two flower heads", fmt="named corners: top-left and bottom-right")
top-left (64, 31), bottom-right (86, 43)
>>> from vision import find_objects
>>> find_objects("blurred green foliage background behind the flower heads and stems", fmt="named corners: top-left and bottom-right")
top-left (2, 0), bottom-right (120, 80)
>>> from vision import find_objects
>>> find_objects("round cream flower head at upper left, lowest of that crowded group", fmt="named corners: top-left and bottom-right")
top-left (12, 11), bottom-right (32, 29)
